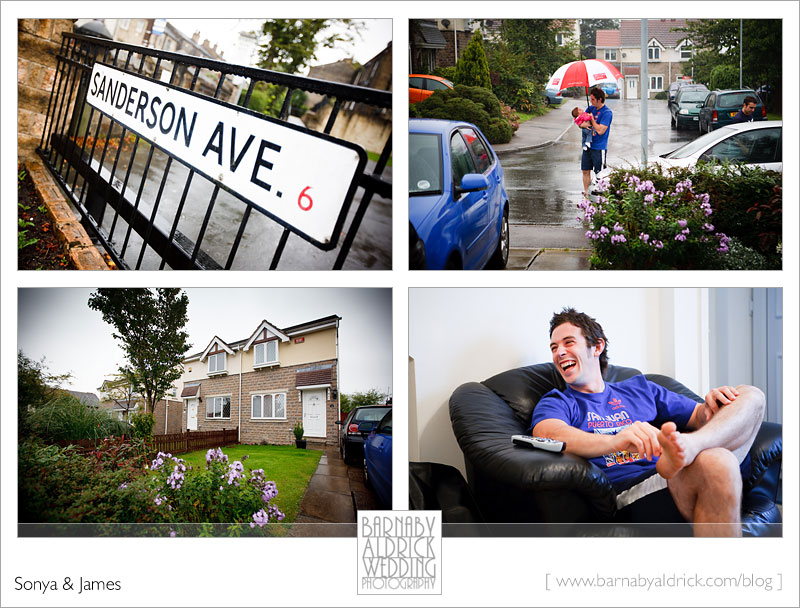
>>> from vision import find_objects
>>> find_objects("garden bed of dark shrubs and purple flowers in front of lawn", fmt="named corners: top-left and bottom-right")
top-left (19, 439), bottom-right (284, 534)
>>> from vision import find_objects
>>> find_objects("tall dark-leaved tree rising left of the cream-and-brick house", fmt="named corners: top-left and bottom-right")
top-left (89, 288), bottom-right (191, 413)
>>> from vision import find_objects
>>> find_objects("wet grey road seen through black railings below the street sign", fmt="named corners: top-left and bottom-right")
top-left (74, 120), bottom-right (392, 270)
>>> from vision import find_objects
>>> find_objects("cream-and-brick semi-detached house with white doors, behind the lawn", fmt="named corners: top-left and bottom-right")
top-left (180, 315), bottom-right (341, 445)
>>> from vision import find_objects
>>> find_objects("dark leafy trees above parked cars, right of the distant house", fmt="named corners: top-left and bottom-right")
top-left (678, 19), bottom-right (783, 107)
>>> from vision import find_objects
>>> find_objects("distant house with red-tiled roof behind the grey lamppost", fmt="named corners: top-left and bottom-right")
top-left (608, 19), bottom-right (694, 99)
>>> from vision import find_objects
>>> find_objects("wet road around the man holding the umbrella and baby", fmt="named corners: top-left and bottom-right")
top-left (502, 99), bottom-right (699, 226)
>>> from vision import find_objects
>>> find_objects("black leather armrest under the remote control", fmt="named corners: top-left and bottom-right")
top-left (450, 382), bottom-right (616, 517)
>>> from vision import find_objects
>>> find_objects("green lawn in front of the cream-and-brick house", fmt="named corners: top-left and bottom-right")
top-left (180, 445), bottom-right (323, 524)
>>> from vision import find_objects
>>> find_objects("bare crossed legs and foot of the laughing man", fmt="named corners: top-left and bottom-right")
top-left (656, 386), bottom-right (765, 536)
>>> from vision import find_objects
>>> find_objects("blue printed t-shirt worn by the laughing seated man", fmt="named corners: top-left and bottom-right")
top-left (530, 376), bottom-right (697, 492)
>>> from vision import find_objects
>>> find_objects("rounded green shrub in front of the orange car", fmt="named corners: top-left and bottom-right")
top-left (416, 85), bottom-right (514, 144)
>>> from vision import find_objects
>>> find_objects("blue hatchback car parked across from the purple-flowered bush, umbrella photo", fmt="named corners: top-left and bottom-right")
top-left (408, 118), bottom-right (509, 270)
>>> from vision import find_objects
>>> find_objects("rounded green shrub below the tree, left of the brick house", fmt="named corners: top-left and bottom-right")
top-left (28, 393), bottom-right (131, 442)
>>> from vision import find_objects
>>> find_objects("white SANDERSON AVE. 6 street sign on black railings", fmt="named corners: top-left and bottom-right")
top-left (86, 63), bottom-right (366, 249)
